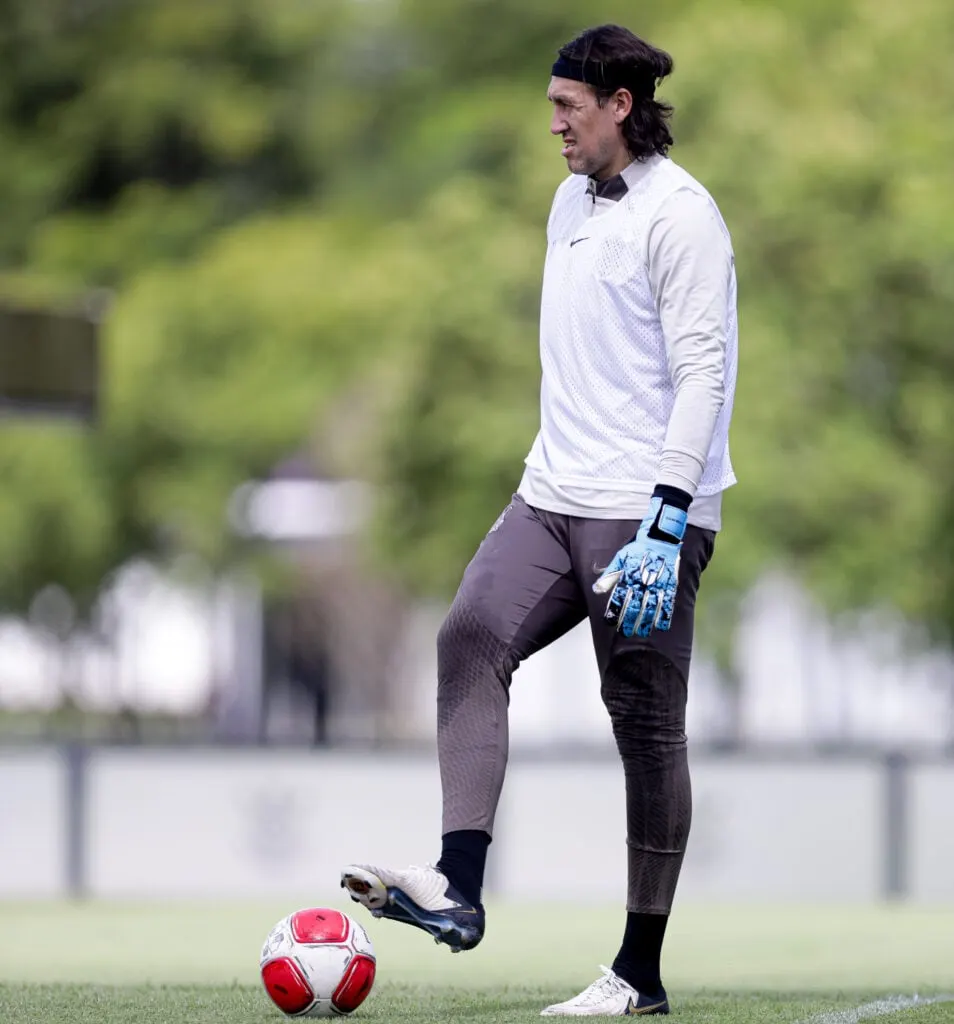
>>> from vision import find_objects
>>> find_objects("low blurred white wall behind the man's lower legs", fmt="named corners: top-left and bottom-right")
top-left (0, 748), bottom-right (954, 903)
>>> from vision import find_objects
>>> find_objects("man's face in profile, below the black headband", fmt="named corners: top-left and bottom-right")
top-left (547, 78), bottom-right (632, 178)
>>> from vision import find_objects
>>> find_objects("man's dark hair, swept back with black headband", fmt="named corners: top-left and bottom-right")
top-left (560, 25), bottom-right (673, 160)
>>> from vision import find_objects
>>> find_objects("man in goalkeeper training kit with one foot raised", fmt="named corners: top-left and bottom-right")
top-left (342, 26), bottom-right (737, 1016)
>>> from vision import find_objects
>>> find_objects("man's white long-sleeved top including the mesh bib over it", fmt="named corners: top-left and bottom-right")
top-left (518, 157), bottom-right (738, 529)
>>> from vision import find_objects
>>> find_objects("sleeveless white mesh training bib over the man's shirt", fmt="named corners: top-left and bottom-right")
top-left (521, 158), bottom-right (738, 514)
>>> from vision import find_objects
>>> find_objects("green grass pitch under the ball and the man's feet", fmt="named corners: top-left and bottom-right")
top-left (0, 901), bottom-right (954, 1024)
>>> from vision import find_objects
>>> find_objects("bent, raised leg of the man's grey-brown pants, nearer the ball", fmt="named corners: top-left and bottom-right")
top-left (437, 499), bottom-right (587, 835)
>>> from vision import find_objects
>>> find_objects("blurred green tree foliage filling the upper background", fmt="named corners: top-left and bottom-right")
top-left (0, 0), bottom-right (954, 651)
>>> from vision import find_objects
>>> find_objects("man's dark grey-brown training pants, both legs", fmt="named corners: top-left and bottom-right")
top-left (437, 496), bottom-right (714, 913)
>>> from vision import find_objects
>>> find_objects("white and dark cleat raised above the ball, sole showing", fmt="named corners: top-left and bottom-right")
top-left (341, 864), bottom-right (484, 952)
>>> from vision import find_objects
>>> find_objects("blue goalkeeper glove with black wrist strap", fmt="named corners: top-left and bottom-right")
top-left (593, 484), bottom-right (692, 637)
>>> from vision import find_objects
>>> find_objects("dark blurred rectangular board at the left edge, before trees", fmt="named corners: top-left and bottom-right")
top-left (0, 304), bottom-right (99, 422)
